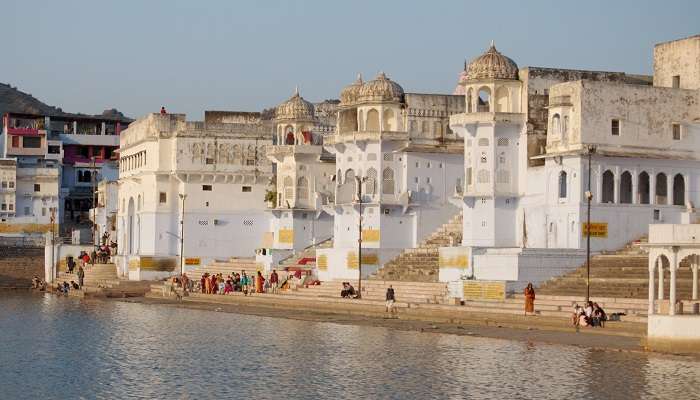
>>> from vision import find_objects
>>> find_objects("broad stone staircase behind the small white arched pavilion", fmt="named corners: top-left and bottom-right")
top-left (537, 238), bottom-right (692, 299)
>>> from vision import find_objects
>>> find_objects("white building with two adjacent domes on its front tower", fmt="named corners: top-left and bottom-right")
top-left (316, 73), bottom-right (465, 280)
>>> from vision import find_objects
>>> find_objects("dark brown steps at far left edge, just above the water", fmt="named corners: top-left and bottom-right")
top-left (0, 246), bottom-right (44, 289)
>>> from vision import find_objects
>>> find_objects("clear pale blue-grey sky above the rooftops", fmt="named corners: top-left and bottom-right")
top-left (0, 0), bottom-right (700, 120)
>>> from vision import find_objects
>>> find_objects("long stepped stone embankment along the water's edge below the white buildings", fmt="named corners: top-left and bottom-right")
top-left (124, 292), bottom-right (660, 351)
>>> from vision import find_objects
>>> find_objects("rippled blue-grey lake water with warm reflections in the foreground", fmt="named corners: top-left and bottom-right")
top-left (0, 293), bottom-right (700, 399)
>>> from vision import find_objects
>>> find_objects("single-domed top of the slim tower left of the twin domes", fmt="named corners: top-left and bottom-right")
top-left (275, 88), bottom-right (316, 145)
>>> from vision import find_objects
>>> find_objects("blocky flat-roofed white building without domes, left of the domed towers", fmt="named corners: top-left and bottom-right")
top-left (116, 112), bottom-right (272, 280)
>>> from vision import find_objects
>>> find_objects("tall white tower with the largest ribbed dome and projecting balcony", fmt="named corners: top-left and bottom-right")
top-left (450, 43), bottom-right (527, 246)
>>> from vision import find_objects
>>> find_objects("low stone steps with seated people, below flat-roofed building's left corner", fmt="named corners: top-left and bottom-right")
top-left (52, 264), bottom-right (153, 297)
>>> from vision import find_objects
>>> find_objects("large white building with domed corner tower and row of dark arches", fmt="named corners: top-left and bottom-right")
top-left (440, 36), bottom-right (700, 289)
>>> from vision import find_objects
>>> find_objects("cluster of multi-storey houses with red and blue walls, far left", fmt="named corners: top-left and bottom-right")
top-left (0, 110), bottom-right (130, 238)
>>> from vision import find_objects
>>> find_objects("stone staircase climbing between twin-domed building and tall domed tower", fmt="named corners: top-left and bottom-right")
top-left (370, 211), bottom-right (463, 282)
